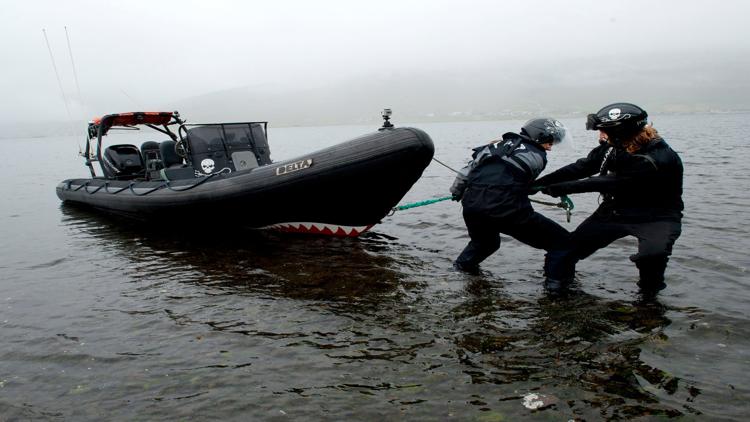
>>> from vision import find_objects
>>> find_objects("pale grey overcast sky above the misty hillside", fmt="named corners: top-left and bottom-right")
top-left (0, 0), bottom-right (750, 126)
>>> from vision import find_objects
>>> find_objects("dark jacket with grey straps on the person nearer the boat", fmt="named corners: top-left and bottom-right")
top-left (462, 133), bottom-right (547, 218)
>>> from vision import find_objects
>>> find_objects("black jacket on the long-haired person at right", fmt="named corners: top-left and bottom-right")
top-left (535, 139), bottom-right (684, 220)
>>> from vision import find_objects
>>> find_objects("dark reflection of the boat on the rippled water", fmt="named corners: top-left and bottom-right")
top-left (61, 203), bottom-right (424, 300)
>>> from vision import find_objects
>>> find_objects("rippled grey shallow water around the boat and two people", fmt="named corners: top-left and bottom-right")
top-left (0, 114), bottom-right (750, 421)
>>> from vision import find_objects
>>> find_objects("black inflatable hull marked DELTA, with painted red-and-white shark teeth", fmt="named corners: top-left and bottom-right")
top-left (57, 128), bottom-right (434, 236)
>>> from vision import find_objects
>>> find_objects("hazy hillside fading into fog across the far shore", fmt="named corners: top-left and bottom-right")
top-left (0, 53), bottom-right (750, 138)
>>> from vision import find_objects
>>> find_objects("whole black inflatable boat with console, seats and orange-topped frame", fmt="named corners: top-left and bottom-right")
top-left (57, 112), bottom-right (434, 236)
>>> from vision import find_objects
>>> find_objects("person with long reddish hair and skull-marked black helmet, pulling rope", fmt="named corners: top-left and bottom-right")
top-left (535, 103), bottom-right (684, 293)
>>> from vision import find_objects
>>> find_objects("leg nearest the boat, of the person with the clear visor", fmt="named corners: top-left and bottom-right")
top-left (456, 211), bottom-right (500, 271)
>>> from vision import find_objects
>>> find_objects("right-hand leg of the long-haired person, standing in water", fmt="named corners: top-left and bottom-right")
top-left (630, 221), bottom-right (682, 292)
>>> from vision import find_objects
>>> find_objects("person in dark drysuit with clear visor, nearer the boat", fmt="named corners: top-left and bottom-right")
top-left (451, 118), bottom-right (569, 273)
